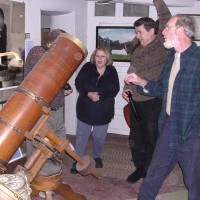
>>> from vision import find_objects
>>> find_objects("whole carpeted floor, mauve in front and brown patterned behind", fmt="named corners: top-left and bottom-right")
top-left (32, 134), bottom-right (185, 200)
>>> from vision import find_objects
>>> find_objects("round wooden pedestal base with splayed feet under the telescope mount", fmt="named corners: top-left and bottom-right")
top-left (31, 172), bottom-right (86, 200)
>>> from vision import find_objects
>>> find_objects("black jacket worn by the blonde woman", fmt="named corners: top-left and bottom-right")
top-left (75, 62), bottom-right (120, 125)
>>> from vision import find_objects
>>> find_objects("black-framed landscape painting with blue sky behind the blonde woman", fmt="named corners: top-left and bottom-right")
top-left (96, 26), bottom-right (135, 62)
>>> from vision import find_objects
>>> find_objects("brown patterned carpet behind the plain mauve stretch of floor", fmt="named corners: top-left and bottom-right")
top-left (64, 133), bottom-right (184, 185)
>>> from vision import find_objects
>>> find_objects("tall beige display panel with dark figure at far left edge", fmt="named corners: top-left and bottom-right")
top-left (0, 0), bottom-right (25, 88)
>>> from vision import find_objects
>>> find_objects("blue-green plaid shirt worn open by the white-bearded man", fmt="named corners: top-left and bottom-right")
top-left (138, 43), bottom-right (200, 148)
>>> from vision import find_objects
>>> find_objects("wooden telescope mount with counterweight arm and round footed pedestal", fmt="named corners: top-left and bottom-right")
top-left (15, 110), bottom-right (101, 200)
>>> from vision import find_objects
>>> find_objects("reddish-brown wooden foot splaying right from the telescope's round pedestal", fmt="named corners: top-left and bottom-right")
top-left (54, 183), bottom-right (87, 200)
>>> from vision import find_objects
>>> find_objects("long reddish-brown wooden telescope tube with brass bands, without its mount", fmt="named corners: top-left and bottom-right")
top-left (0, 33), bottom-right (87, 171)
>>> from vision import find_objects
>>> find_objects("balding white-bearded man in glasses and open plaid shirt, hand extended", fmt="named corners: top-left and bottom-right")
top-left (125, 15), bottom-right (200, 200)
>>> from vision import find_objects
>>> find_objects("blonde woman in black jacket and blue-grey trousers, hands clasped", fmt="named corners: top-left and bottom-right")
top-left (70, 47), bottom-right (119, 174)
